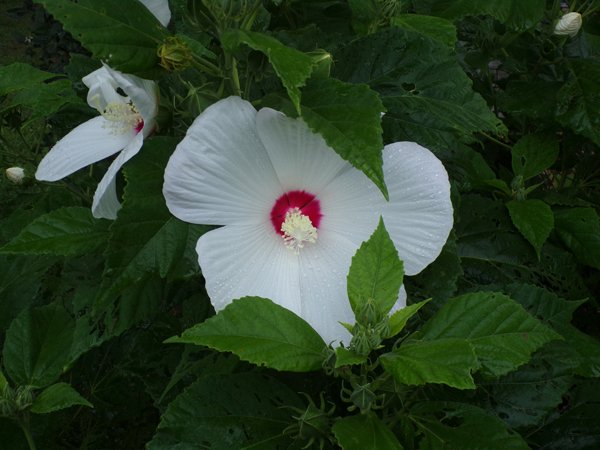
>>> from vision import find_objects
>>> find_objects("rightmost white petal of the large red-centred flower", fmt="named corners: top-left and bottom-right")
top-left (383, 142), bottom-right (453, 275)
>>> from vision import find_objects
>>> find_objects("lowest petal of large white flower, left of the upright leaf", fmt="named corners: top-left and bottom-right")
top-left (299, 230), bottom-right (358, 344)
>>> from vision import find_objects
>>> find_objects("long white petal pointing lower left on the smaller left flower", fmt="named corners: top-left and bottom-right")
top-left (35, 117), bottom-right (134, 181)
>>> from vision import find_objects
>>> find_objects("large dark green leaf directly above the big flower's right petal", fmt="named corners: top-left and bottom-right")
top-left (335, 28), bottom-right (504, 150)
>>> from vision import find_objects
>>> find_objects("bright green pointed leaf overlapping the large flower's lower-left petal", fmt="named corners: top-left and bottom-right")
top-left (166, 297), bottom-right (325, 372)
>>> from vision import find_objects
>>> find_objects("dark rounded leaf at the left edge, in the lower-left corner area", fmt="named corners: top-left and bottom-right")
top-left (2, 305), bottom-right (75, 388)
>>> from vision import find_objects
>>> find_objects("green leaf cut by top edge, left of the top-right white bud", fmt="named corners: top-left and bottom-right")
top-left (415, 0), bottom-right (545, 30)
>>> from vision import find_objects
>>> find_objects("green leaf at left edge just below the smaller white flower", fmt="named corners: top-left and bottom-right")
top-left (0, 206), bottom-right (110, 256)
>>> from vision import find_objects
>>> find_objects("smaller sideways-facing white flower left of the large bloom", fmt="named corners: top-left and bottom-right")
top-left (35, 65), bottom-right (158, 219)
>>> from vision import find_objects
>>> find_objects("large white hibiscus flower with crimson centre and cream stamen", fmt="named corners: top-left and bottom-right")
top-left (163, 97), bottom-right (452, 343)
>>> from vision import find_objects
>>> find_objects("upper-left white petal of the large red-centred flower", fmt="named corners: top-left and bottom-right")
top-left (163, 97), bottom-right (283, 225)
